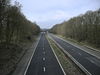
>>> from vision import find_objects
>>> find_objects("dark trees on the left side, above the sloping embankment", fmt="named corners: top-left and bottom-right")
top-left (0, 0), bottom-right (40, 44)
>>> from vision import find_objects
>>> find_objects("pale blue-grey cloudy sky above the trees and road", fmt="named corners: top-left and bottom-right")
top-left (12, 0), bottom-right (100, 28)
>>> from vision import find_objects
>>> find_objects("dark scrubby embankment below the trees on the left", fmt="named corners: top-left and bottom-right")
top-left (0, 36), bottom-right (37, 75)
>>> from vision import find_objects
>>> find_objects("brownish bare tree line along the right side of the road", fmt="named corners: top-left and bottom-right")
top-left (50, 9), bottom-right (100, 47)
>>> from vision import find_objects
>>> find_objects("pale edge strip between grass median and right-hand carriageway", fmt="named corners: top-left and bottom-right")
top-left (49, 36), bottom-right (92, 75)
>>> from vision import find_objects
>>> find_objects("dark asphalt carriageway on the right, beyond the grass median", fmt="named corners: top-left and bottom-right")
top-left (49, 34), bottom-right (100, 75)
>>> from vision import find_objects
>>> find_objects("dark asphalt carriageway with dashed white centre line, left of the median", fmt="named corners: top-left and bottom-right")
top-left (25, 33), bottom-right (64, 75)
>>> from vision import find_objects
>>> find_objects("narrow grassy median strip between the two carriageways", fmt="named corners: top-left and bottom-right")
top-left (48, 38), bottom-right (85, 75)
